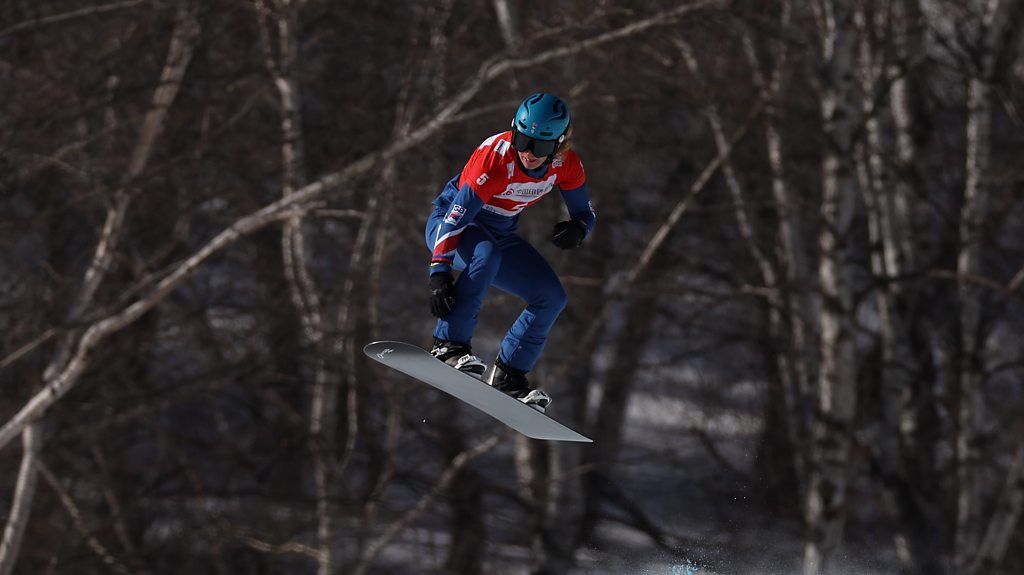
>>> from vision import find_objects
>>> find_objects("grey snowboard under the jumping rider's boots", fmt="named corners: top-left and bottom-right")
top-left (362, 342), bottom-right (593, 443)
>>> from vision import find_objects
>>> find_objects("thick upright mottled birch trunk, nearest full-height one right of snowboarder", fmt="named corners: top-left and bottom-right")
top-left (804, 0), bottom-right (857, 575)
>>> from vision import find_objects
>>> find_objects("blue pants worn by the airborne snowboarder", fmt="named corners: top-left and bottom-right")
top-left (426, 208), bottom-right (566, 371)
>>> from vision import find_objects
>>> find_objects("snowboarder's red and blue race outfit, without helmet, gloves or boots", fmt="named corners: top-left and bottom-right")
top-left (426, 131), bottom-right (596, 371)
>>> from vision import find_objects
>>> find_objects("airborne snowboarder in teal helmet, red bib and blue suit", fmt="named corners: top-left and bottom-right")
top-left (426, 93), bottom-right (596, 411)
